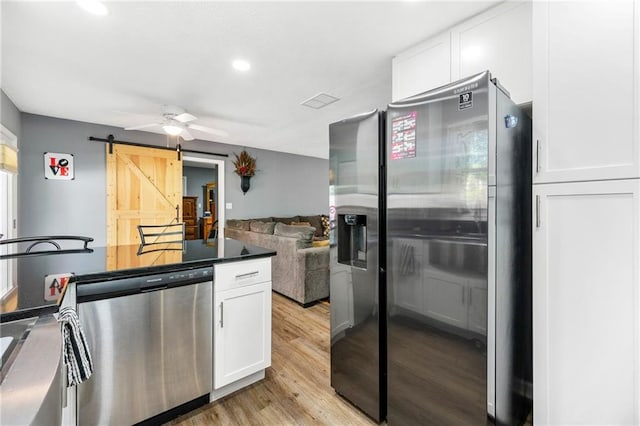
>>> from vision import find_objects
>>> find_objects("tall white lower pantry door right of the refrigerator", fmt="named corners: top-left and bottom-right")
top-left (533, 179), bottom-right (640, 425)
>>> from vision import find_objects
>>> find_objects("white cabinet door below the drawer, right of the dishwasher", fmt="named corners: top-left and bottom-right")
top-left (213, 282), bottom-right (271, 389)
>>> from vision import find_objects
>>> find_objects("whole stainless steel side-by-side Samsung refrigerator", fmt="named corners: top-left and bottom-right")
top-left (329, 71), bottom-right (532, 425)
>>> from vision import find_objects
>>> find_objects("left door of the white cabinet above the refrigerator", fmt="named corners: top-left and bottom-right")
top-left (391, 32), bottom-right (451, 101)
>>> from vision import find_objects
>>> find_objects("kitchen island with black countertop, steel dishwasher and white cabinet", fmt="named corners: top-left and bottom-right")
top-left (0, 239), bottom-right (275, 425)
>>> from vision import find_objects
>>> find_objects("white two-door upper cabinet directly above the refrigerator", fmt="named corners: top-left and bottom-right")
top-left (392, 1), bottom-right (532, 103)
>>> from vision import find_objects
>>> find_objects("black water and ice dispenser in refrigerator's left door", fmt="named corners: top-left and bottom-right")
top-left (338, 214), bottom-right (367, 269)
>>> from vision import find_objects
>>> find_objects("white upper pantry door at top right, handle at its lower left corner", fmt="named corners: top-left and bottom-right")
top-left (533, 0), bottom-right (640, 183)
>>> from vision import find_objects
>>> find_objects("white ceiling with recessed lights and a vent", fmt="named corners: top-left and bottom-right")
top-left (0, 0), bottom-right (498, 158)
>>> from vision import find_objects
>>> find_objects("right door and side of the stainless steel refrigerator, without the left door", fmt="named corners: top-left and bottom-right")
top-left (385, 71), bottom-right (531, 425)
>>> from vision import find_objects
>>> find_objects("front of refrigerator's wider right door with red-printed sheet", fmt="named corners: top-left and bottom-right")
top-left (386, 72), bottom-right (495, 424)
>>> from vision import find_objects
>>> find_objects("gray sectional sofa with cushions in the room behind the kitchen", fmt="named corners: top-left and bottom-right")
top-left (224, 215), bottom-right (329, 307)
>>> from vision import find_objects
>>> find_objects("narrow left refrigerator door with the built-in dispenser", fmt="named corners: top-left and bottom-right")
top-left (329, 111), bottom-right (386, 421)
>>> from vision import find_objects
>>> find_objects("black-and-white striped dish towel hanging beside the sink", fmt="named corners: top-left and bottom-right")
top-left (58, 306), bottom-right (93, 387)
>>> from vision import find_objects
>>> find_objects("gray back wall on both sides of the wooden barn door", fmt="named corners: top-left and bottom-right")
top-left (18, 113), bottom-right (329, 246)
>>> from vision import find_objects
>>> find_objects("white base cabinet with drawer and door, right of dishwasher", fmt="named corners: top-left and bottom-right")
top-left (213, 258), bottom-right (271, 389)
